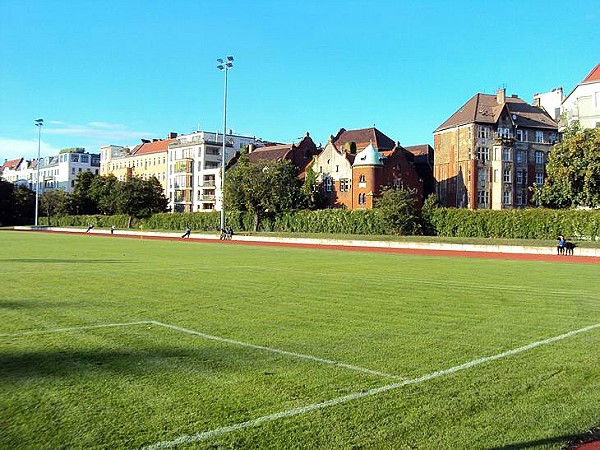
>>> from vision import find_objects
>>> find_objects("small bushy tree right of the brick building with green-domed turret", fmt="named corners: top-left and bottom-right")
top-left (375, 187), bottom-right (421, 235)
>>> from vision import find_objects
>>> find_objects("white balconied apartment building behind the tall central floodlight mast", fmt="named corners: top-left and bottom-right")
top-left (167, 131), bottom-right (263, 212)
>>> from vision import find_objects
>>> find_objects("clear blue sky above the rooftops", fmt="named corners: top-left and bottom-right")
top-left (0, 0), bottom-right (600, 162)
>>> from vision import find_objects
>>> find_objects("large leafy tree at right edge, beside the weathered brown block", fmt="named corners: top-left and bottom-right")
top-left (533, 122), bottom-right (600, 208)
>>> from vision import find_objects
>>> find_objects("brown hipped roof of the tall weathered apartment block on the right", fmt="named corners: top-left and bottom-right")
top-left (434, 94), bottom-right (557, 133)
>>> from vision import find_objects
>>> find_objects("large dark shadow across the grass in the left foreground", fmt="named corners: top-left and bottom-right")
top-left (0, 346), bottom-right (256, 381)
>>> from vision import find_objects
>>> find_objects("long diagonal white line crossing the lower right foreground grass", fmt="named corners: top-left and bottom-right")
top-left (142, 323), bottom-right (600, 450)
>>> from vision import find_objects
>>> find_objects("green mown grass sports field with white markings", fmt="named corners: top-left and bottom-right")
top-left (0, 231), bottom-right (600, 449)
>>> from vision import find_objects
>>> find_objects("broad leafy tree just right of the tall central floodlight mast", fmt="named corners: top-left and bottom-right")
top-left (224, 154), bottom-right (306, 231)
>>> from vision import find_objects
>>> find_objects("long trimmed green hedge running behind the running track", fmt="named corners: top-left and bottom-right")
top-left (40, 208), bottom-right (600, 240)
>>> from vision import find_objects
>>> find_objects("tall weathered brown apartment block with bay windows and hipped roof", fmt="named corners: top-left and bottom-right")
top-left (434, 89), bottom-right (558, 209)
